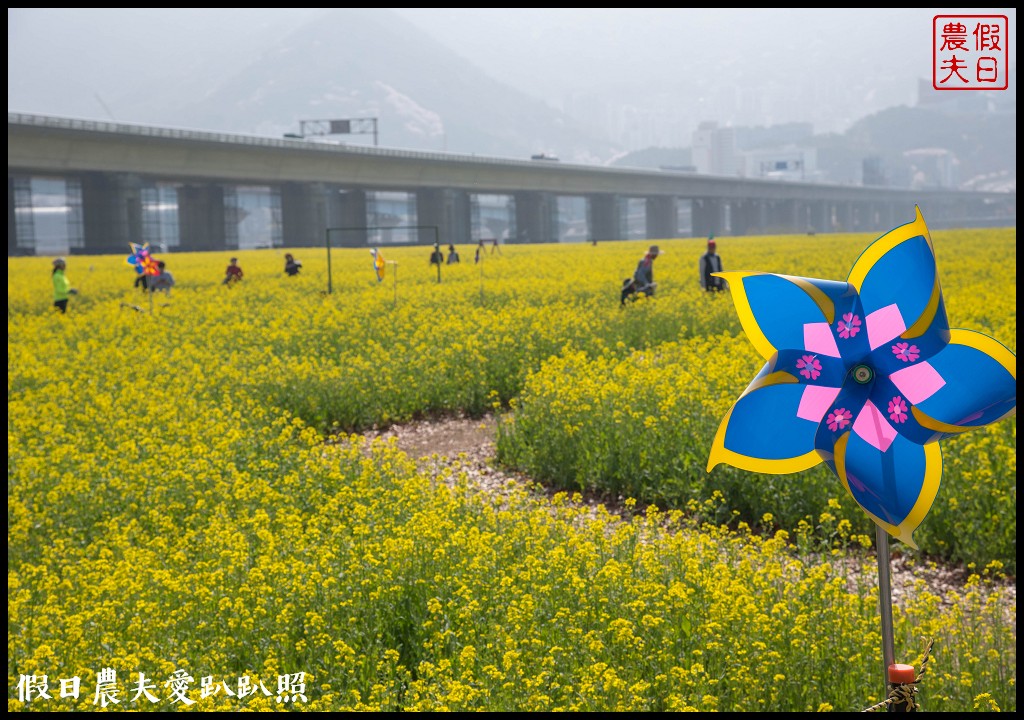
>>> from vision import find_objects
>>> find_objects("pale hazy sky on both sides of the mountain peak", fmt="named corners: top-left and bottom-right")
top-left (7, 8), bottom-right (1017, 141)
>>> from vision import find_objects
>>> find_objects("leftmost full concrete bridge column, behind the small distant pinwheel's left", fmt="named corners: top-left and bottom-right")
top-left (81, 172), bottom-right (142, 255)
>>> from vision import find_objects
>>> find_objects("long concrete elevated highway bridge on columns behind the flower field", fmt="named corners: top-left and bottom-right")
top-left (7, 113), bottom-right (1017, 255)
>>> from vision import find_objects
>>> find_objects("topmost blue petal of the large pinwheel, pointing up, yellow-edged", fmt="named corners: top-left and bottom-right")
top-left (848, 203), bottom-right (949, 349)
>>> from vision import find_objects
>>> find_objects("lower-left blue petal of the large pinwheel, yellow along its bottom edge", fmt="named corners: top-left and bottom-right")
top-left (708, 363), bottom-right (839, 474)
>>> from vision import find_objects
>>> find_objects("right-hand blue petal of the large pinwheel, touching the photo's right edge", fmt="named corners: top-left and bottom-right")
top-left (905, 329), bottom-right (1017, 439)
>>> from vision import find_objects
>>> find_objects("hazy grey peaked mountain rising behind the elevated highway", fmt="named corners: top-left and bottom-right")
top-left (162, 8), bottom-right (614, 162)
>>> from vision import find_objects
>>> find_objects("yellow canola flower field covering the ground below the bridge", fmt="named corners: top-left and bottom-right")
top-left (8, 229), bottom-right (1016, 712)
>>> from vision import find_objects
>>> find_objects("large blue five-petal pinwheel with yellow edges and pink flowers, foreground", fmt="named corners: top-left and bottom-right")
top-left (708, 209), bottom-right (1017, 548)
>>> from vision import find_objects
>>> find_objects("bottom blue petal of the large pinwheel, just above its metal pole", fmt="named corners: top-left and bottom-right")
top-left (825, 431), bottom-right (942, 549)
